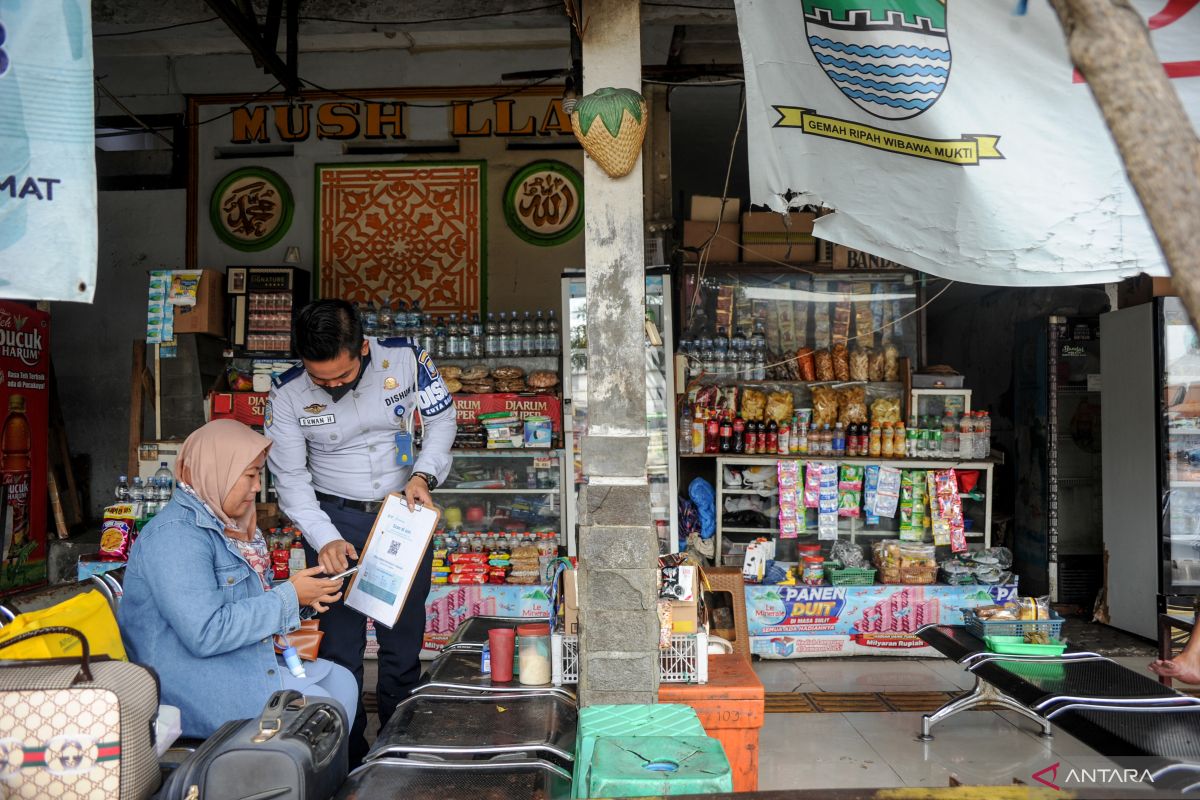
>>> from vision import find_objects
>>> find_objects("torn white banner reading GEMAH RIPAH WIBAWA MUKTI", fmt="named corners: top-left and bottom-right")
top-left (737, 0), bottom-right (1200, 285)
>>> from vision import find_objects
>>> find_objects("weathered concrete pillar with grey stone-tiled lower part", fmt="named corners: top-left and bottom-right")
top-left (580, 0), bottom-right (659, 705)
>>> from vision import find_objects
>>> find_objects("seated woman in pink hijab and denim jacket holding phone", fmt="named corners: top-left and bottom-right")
top-left (119, 420), bottom-right (358, 738)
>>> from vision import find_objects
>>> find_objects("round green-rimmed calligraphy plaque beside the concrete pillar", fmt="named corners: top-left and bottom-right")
top-left (504, 161), bottom-right (583, 246)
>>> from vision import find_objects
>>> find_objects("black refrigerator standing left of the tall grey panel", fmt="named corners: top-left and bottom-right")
top-left (1013, 315), bottom-right (1104, 609)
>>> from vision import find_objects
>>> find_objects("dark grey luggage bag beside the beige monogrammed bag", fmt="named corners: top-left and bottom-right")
top-left (158, 690), bottom-right (349, 800)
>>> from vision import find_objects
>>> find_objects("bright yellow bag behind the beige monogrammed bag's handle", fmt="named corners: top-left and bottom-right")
top-left (0, 589), bottom-right (128, 661)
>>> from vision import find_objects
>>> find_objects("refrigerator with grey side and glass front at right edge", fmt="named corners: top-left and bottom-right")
top-left (1100, 297), bottom-right (1200, 639)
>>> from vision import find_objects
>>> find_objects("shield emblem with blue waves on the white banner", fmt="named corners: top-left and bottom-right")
top-left (803, 0), bottom-right (950, 120)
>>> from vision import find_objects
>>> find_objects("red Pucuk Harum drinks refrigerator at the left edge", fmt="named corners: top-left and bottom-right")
top-left (0, 301), bottom-right (50, 595)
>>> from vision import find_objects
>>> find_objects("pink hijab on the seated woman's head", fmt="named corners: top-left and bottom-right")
top-left (178, 420), bottom-right (271, 534)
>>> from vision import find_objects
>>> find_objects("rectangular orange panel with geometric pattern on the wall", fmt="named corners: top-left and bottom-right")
top-left (317, 161), bottom-right (486, 315)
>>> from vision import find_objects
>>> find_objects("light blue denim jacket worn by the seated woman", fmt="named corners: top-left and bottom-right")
top-left (118, 489), bottom-right (300, 736)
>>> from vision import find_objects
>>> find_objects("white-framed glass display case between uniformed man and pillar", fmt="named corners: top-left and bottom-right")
top-left (434, 449), bottom-right (565, 545)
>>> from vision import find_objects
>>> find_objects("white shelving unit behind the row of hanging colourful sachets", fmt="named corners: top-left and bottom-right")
top-left (716, 456), bottom-right (994, 566)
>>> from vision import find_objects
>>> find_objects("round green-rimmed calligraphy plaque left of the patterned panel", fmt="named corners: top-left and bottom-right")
top-left (209, 167), bottom-right (294, 252)
